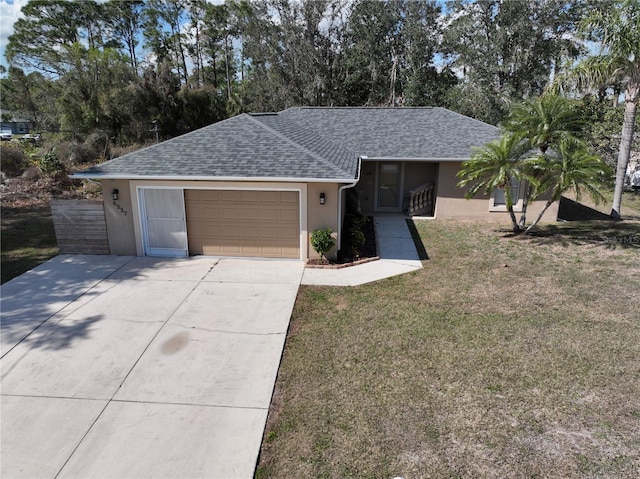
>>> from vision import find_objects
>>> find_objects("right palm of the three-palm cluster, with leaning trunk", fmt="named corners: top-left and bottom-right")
top-left (526, 139), bottom-right (611, 233)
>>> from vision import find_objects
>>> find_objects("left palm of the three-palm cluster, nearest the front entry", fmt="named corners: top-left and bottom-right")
top-left (457, 132), bottom-right (531, 233)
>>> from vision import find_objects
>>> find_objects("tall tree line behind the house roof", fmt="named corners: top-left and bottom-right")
top-left (2, 0), bottom-right (602, 143)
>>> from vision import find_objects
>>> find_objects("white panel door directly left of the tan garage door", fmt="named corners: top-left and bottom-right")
top-left (139, 188), bottom-right (189, 256)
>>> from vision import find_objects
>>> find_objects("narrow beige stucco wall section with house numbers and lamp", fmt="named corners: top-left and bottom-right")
top-left (102, 180), bottom-right (136, 256)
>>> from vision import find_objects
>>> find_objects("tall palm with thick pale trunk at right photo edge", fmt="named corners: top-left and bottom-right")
top-left (569, 0), bottom-right (640, 220)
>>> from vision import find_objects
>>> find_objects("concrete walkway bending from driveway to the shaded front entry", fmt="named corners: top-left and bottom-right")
top-left (302, 214), bottom-right (422, 286)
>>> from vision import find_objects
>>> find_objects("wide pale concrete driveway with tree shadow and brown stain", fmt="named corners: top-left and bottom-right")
top-left (0, 255), bottom-right (304, 479)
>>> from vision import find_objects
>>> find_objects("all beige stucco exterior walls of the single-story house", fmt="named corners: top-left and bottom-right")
top-left (102, 162), bottom-right (558, 259)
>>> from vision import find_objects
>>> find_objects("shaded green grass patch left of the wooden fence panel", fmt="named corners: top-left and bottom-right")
top-left (1, 206), bottom-right (58, 283)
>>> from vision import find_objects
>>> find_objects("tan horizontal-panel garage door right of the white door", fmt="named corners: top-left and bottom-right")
top-left (184, 190), bottom-right (300, 258)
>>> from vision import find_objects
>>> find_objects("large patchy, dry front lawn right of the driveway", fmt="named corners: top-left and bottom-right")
top-left (256, 221), bottom-right (640, 479)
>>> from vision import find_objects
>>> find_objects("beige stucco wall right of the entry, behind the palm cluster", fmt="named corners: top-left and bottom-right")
top-left (435, 162), bottom-right (558, 222)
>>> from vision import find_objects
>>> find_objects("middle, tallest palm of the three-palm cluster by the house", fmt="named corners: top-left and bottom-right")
top-left (502, 92), bottom-right (585, 228)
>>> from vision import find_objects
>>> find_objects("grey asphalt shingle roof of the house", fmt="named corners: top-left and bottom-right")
top-left (76, 107), bottom-right (499, 182)
